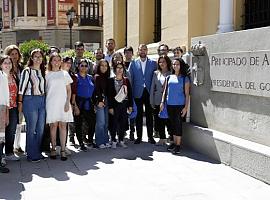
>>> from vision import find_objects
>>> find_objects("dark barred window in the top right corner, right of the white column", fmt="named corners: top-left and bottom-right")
top-left (244, 0), bottom-right (270, 29)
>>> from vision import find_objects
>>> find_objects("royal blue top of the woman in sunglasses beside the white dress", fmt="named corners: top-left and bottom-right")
top-left (76, 74), bottom-right (95, 110)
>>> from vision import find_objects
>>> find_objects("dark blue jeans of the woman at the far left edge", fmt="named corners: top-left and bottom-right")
top-left (5, 107), bottom-right (19, 155)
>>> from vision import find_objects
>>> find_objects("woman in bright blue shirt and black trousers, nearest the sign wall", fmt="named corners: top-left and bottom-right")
top-left (160, 58), bottom-right (190, 154)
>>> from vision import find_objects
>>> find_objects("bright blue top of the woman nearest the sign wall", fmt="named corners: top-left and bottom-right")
top-left (167, 74), bottom-right (189, 105)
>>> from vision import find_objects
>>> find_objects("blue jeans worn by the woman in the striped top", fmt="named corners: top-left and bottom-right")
top-left (23, 95), bottom-right (45, 160)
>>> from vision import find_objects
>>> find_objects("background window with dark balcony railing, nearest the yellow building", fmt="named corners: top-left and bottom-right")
top-left (80, 0), bottom-right (99, 26)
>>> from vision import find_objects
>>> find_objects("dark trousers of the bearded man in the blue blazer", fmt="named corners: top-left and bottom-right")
top-left (135, 88), bottom-right (153, 139)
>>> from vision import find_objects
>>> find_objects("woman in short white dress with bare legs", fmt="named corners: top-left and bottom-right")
top-left (46, 53), bottom-right (73, 161)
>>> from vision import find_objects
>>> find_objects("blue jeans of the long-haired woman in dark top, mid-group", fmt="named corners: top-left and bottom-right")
top-left (95, 106), bottom-right (109, 146)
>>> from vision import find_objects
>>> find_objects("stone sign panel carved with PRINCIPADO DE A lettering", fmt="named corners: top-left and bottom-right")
top-left (209, 51), bottom-right (270, 97)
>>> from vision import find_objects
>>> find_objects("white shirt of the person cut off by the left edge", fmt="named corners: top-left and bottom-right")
top-left (0, 71), bottom-right (9, 106)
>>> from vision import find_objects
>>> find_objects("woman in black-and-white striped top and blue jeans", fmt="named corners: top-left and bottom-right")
top-left (18, 49), bottom-right (45, 162)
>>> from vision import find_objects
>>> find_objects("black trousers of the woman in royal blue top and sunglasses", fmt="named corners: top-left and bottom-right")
top-left (74, 109), bottom-right (96, 145)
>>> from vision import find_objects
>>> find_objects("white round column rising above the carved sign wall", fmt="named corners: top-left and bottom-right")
top-left (217, 0), bottom-right (233, 33)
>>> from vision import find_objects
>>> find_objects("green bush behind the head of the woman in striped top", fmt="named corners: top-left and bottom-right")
top-left (19, 40), bottom-right (49, 65)
